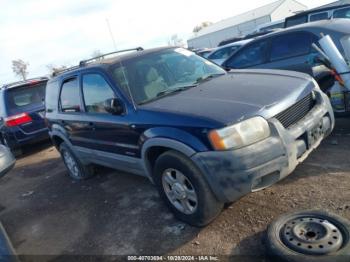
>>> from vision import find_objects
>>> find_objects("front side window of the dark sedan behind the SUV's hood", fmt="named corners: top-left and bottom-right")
top-left (226, 41), bottom-right (268, 68)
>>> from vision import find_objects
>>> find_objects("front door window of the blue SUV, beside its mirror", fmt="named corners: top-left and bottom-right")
top-left (83, 74), bottom-right (115, 113)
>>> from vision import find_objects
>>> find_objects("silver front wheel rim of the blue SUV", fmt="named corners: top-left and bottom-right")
top-left (162, 168), bottom-right (198, 215)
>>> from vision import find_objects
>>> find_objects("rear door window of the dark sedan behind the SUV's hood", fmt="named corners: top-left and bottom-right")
top-left (271, 33), bottom-right (312, 61)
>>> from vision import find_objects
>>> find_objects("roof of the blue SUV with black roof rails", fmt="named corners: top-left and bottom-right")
top-left (51, 46), bottom-right (175, 81)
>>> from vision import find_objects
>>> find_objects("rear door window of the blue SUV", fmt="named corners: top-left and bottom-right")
top-left (60, 78), bottom-right (81, 112)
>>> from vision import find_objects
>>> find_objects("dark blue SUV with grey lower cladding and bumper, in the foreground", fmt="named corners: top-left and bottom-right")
top-left (46, 47), bottom-right (334, 226)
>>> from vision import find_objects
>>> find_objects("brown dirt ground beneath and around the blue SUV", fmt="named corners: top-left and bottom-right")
top-left (0, 119), bottom-right (350, 262)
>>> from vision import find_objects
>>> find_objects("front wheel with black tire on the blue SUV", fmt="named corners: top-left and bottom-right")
top-left (153, 151), bottom-right (224, 227)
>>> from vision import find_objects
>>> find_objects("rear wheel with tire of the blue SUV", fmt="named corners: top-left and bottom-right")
top-left (59, 142), bottom-right (94, 180)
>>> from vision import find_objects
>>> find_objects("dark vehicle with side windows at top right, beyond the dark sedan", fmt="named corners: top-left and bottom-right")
top-left (284, 4), bottom-right (350, 28)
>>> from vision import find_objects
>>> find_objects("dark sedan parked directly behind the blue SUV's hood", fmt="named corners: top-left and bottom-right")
top-left (223, 19), bottom-right (350, 89)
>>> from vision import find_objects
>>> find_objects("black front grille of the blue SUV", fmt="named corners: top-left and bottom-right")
top-left (275, 93), bottom-right (316, 128)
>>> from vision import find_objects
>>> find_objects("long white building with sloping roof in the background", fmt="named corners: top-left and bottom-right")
top-left (187, 0), bottom-right (307, 48)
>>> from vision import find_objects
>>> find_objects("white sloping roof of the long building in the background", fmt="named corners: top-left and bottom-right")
top-left (189, 0), bottom-right (306, 40)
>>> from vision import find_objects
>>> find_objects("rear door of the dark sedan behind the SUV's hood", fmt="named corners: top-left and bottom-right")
top-left (258, 32), bottom-right (317, 75)
